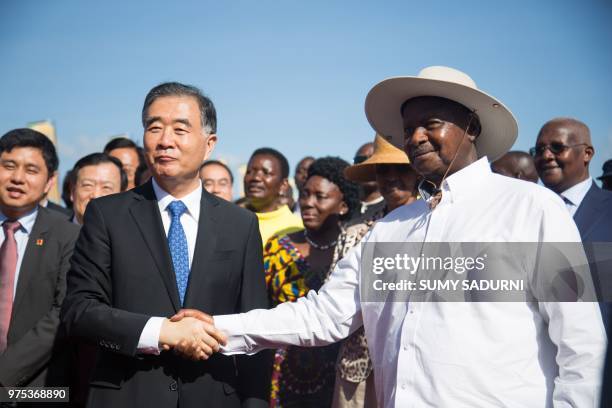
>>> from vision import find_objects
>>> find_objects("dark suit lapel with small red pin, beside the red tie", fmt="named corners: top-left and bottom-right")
top-left (12, 207), bottom-right (50, 316)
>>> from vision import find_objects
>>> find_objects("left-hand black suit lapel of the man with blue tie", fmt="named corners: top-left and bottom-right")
top-left (129, 181), bottom-right (181, 311)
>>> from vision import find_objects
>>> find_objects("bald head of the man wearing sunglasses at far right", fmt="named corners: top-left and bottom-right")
top-left (534, 118), bottom-right (595, 194)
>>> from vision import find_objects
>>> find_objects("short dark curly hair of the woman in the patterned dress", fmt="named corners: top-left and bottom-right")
top-left (306, 157), bottom-right (361, 220)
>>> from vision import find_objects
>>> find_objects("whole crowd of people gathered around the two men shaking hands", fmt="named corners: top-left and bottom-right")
top-left (0, 67), bottom-right (612, 407)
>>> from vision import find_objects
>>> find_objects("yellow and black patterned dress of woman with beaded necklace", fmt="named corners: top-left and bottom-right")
top-left (264, 235), bottom-right (339, 408)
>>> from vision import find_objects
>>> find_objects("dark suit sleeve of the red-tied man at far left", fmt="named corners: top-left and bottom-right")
top-left (0, 223), bottom-right (78, 386)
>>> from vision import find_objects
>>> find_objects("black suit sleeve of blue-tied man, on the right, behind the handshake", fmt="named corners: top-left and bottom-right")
top-left (234, 216), bottom-right (273, 408)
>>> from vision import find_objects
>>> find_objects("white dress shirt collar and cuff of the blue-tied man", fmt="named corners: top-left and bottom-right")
top-left (137, 178), bottom-right (202, 354)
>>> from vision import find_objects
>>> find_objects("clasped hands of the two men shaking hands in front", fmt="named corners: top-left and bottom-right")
top-left (159, 309), bottom-right (227, 361)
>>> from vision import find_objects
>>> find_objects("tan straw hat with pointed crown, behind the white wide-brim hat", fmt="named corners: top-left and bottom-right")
top-left (344, 134), bottom-right (410, 182)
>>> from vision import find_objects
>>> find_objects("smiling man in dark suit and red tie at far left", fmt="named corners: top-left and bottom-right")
top-left (0, 129), bottom-right (79, 387)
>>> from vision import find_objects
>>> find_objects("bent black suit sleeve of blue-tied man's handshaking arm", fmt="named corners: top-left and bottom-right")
top-left (62, 200), bottom-right (150, 356)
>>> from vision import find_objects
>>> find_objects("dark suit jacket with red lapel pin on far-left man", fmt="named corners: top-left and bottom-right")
top-left (0, 207), bottom-right (79, 387)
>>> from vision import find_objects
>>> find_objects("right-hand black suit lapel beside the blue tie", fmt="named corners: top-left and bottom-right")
top-left (185, 189), bottom-right (219, 305)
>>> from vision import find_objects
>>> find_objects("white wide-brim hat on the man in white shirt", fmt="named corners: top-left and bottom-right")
top-left (365, 66), bottom-right (518, 161)
